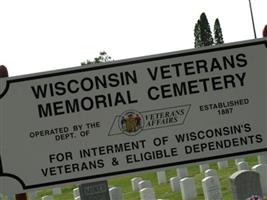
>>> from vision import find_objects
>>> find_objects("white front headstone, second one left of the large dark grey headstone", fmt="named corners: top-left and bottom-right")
top-left (180, 177), bottom-right (197, 200)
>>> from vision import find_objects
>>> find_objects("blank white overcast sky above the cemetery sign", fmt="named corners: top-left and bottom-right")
top-left (0, 0), bottom-right (267, 76)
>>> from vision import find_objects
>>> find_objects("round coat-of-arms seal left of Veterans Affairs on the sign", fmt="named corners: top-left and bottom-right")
top-left (119, 110), bottom-right (144, 136)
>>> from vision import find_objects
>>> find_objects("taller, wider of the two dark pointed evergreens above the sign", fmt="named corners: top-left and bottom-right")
top-left (194, 12), bottom-right (213, 47)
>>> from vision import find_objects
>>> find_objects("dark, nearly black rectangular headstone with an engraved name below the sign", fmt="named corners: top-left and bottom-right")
top-left (79, 181), bottom-right (110, 200)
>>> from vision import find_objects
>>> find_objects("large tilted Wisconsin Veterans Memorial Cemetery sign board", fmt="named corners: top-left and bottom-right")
top-left (0, 39), bottom-right (267, 192)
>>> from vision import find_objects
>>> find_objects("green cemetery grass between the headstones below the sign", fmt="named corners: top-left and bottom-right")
top-left (4, 157), bottom-right (267, 200)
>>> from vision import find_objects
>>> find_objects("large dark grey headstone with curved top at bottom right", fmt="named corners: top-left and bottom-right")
top-left (230, 170), bottom-right (263, 200)
